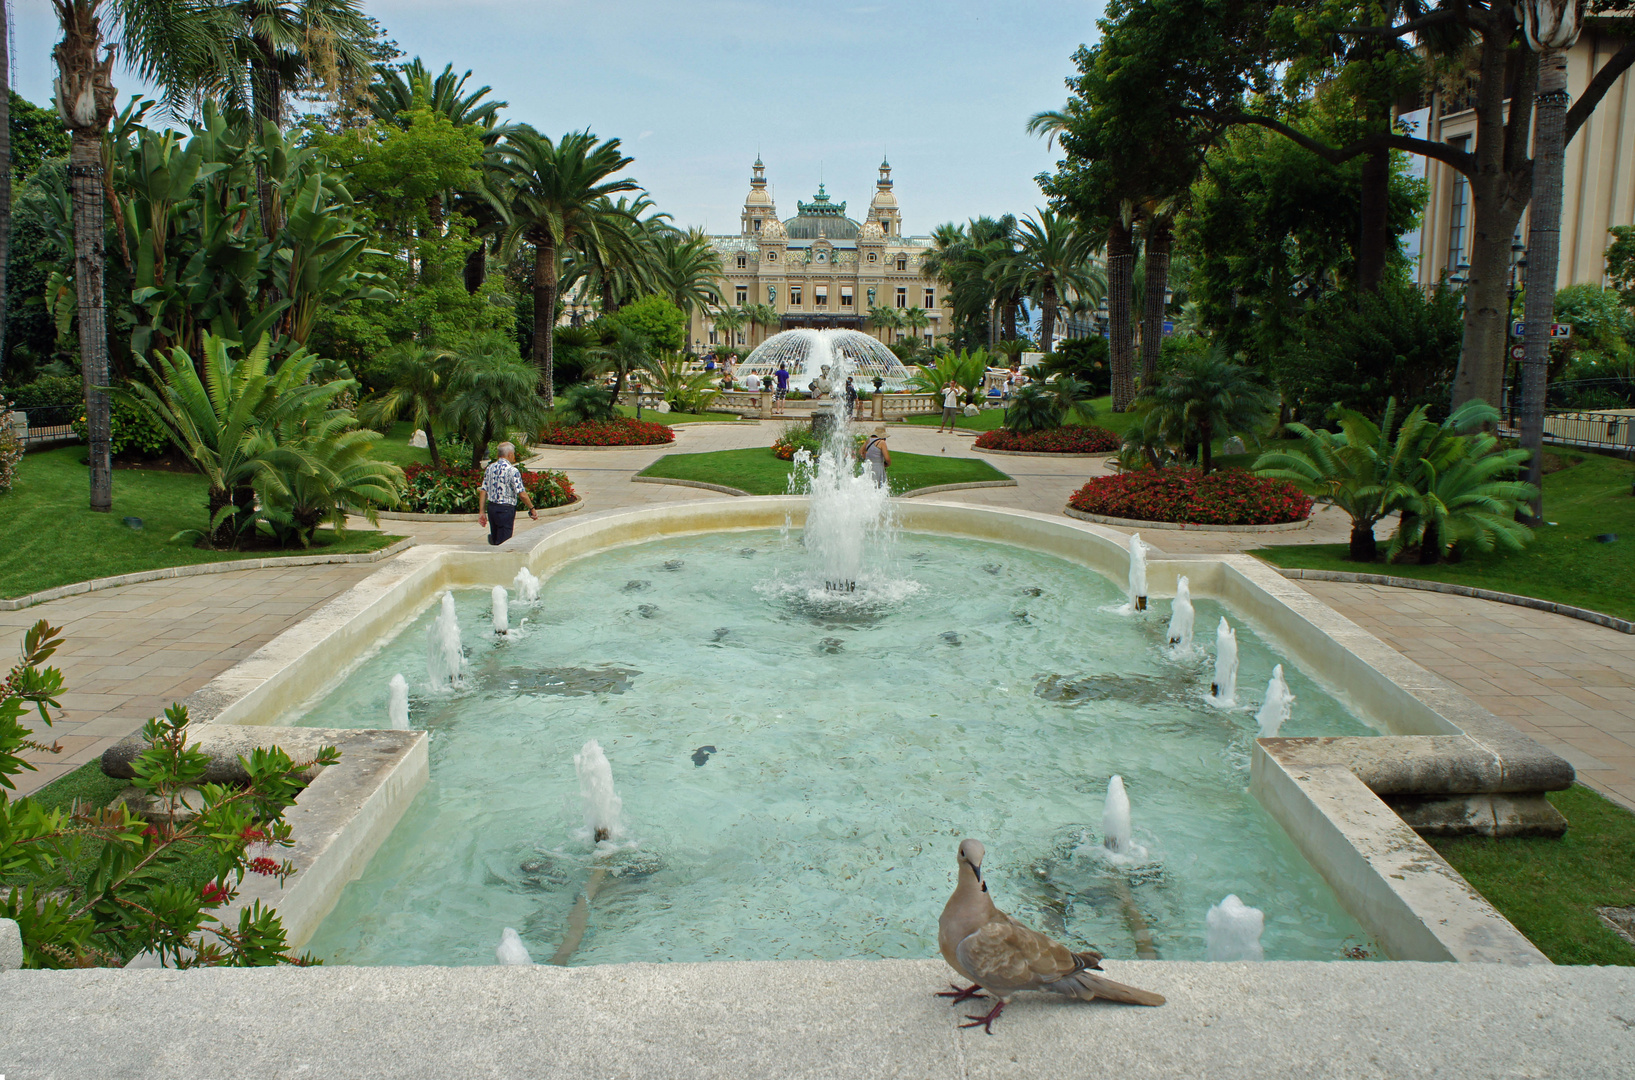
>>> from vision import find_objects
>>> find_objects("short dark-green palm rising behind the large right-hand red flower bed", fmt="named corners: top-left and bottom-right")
top-left (1140, 355), bottom-right (1275, 475)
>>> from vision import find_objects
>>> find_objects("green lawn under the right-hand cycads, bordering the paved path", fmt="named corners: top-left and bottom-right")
top-left (1252, 453), bottom-right (1635, 619)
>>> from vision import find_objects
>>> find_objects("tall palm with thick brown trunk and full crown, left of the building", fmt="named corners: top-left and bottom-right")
top-left (499, 127), bottom-right (638, 405)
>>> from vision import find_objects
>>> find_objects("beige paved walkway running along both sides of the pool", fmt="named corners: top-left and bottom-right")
top-left (0, 420), bottom-right (1635, 809)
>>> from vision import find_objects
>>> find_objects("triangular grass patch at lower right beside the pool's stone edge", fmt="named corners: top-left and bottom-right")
top-left (1431, 784), bottom-right (1635, 966)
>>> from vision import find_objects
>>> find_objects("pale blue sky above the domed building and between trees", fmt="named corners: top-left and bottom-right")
top-left (10, 0), bottom-right (1102, 234)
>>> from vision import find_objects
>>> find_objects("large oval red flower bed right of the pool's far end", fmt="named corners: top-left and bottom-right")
top-left (1068, 469), bottom-right (1311, 524)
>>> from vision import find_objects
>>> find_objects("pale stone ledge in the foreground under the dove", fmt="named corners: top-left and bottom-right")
top-left (0, 954), bottom-right (1635, 1080)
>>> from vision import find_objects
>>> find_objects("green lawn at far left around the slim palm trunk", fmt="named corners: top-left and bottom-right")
top-left (0, 446), bottom-right (399, 596)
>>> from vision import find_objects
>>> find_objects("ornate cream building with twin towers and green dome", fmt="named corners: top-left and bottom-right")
top-left (692, 157), bottom-right (945, 353)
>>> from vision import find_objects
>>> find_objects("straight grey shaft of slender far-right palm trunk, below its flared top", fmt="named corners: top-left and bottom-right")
top-left (1522, 49), bottom-right (1568, 524)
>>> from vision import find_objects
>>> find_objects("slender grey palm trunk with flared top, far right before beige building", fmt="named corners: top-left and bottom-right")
top-left (1516, 0), bottom-right (1584, 526)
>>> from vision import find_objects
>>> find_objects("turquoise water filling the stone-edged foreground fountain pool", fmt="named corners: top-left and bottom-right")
top-left (299, 531), bottom-right (1375, 964)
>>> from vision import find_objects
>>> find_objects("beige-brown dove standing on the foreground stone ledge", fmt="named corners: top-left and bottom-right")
top-left (937, 840), bottom-right (1164, 1034)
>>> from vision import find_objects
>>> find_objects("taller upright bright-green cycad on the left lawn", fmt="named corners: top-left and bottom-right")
top-left (118, 335), bottom-right (353, 546)
